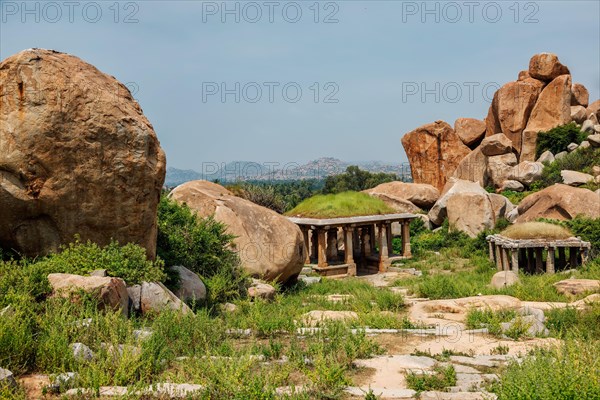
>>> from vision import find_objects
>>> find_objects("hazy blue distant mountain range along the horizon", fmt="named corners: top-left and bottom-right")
top-left (165, 157), bottom-right (410, 187)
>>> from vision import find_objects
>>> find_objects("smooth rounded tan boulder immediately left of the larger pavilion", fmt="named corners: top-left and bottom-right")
top-left (170, 181), bottom-right (306, 282)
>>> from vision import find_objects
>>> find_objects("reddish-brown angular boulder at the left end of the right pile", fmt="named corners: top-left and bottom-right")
top-left (402, 121), bottom-right (471, 190)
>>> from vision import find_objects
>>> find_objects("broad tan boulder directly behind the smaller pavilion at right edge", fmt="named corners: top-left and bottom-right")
top-left (517, 183), bottom-right (600, 222)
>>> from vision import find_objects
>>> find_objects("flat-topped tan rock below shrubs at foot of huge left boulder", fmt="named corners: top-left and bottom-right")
top-left (48, 274), bottom-right (129, 316)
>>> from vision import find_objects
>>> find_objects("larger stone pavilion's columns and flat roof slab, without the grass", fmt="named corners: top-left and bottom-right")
top-left (288, 213), bottom-right (417, 276)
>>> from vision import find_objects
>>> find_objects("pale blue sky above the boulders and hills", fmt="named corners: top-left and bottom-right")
top-left (0, 0), bottom-right (600, 170)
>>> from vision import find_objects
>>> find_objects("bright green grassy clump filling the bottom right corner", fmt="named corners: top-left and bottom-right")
top-left (492, 338), bottom-right (600, 400)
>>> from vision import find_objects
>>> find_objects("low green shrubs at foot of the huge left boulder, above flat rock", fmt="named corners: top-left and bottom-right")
top-left (38, 240), bottom-right (166, 284)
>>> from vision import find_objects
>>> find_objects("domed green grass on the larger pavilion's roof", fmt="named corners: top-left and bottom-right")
top-left (286, 192), bottom-right (394, 218)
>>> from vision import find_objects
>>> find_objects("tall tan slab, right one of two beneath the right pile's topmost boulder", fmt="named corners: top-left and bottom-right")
top-left (520, 75), bottom-right (571, 161)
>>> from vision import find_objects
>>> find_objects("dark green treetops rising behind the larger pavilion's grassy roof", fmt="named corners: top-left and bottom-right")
top-left (323, 165), bottom-right (398, 194)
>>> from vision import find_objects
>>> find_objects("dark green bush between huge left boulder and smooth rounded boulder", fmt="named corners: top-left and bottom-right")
top-left (157, 195), bottom-right (246, 301)
